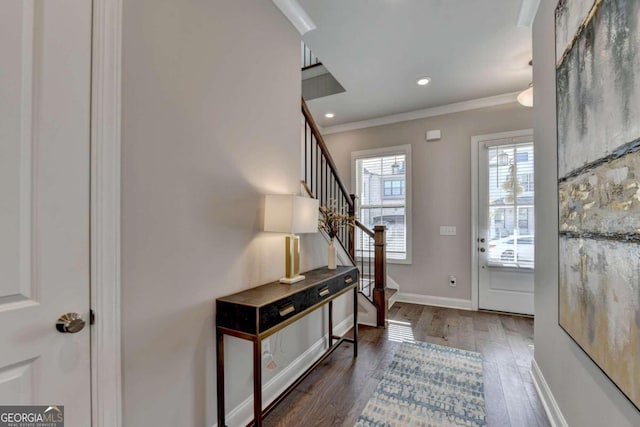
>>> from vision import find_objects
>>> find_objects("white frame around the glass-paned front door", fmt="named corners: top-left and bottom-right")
top-left (471, 129), bottom-right (533, 311)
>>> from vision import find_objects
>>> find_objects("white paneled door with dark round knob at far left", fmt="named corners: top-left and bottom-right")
top-left (0, 0), bottom-right (92, 427)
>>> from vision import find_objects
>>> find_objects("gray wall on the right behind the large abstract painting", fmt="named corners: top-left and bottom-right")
top-left (533, 0), bottom-right (640, 427)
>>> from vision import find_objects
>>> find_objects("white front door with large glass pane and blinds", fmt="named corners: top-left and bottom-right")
top-left (476, 131), bottom-right (535, 314)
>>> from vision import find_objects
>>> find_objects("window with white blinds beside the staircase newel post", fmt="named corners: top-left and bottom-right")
top-left (353, 146), bottom-right (410, 262)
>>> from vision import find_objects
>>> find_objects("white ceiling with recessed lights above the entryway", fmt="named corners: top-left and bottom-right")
top-left (299, 0), bottom-right (531, 127)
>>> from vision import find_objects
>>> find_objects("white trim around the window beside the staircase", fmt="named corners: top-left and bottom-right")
top-left (351, 144), bottom-right (413, 264)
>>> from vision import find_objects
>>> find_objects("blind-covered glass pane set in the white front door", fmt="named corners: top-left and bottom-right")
top-left (487, 142), bottom-right (535, 268)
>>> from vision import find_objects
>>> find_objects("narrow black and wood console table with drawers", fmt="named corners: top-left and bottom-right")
top-left (216, 266), bottom-right (358, 427)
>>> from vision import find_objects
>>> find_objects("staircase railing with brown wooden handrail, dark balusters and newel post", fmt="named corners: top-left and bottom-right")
top-left (302, 93), bottom-right (390, 327)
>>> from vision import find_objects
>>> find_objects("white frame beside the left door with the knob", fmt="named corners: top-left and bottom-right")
top-left (90, 0), bottom-right (122, 427)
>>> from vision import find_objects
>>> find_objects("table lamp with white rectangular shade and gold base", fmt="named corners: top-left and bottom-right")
top-left (264, 194), bottom-right (319, 283)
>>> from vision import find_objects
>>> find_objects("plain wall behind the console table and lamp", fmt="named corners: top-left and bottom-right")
top-left (122, 0), bottom-right (347, 427)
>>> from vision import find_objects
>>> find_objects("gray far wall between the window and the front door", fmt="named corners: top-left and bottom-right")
top-left (325, 103), bottom-right (532, 300)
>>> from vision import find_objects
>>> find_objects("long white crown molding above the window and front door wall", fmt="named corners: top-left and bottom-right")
top-left (321, 92), bottom-right (520, 135)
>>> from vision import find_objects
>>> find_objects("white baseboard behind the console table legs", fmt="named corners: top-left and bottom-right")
top-left (213, 316), bottom-right (353, 427)
